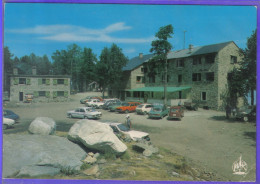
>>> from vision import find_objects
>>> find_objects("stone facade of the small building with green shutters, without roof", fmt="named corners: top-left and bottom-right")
top-left (10, 76), bottom-right (70, 102)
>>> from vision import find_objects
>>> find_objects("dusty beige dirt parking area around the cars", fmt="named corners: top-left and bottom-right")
top-left (4, 93), bottom-right (256, 181)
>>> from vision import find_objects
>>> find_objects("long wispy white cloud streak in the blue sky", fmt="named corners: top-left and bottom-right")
top-left (6, 22), bottom-right (154, 43)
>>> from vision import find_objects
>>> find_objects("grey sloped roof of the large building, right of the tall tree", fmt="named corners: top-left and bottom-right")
top-left (167, 41), bottom-right (234, 59)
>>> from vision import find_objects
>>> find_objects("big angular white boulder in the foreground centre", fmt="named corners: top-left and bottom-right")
top-left (68, 120), bottom-right (127, 155)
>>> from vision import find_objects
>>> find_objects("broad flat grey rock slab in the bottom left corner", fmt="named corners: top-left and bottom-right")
top-left (3, 134), bottom-right (86, 178)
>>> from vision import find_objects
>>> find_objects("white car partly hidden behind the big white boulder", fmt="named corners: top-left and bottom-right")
top-left (109, 123), bottom-right (150, 141)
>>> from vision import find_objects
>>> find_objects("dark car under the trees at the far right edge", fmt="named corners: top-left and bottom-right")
top-left (235, 105), bottom-right (256, 122)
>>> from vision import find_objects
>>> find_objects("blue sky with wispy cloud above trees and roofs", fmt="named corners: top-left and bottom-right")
top-left (4, 3), bottom-right (257, 59)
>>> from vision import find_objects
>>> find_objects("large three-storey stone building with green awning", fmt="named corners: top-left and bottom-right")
top-left (125, 41), bottom-right (243, 110)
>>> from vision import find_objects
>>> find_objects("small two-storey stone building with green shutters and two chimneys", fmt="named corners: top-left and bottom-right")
top-left (10, 68), bottom-right (70, 102)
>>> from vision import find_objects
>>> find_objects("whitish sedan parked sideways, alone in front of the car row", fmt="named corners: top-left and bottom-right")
top-left (67, 107), bottom-right (102, 119)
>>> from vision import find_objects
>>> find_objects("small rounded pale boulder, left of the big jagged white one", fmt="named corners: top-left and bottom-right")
top-left (29, 117), bottom-right (56, 135)
